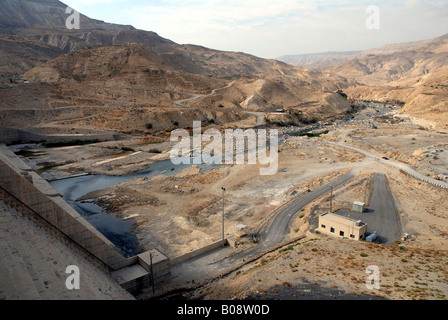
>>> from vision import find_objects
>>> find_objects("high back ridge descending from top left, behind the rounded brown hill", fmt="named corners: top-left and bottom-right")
top-left (0, 0), bottom-right (353, 91)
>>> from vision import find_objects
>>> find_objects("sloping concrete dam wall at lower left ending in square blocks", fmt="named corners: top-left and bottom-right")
top-left (0, 145), bottom-right (171, 291)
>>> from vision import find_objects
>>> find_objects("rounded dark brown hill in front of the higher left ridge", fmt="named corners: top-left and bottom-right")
top-left (0, 44), bottom-right (247, 133)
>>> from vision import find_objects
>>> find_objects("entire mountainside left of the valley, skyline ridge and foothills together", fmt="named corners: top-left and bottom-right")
top-left (0, 0), bottom-right (356, 132)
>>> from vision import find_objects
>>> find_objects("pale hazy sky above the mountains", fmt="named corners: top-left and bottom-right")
top-left (62, 0), bottom-right (448, 58)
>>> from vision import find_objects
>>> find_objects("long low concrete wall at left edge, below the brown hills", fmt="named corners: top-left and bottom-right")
top-left (0, 127), bottom-right (119, 145)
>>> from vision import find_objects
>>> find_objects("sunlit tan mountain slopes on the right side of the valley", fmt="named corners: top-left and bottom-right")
top-left (280, 34), bottom-right (448, 128)
